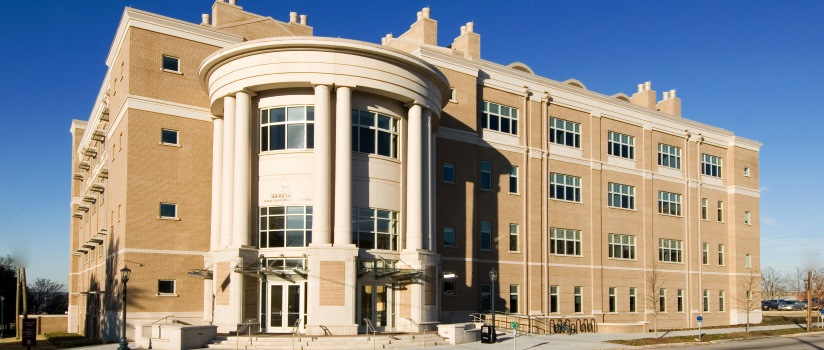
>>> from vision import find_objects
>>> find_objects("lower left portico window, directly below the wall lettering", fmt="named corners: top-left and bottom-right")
top-left (259, 205), bottom-right (312, 248)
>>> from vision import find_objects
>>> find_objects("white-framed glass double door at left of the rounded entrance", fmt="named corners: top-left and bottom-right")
top-left (266, 283), bottom-right (306, 333)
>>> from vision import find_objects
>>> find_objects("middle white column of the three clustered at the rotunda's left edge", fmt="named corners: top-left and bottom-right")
top-left (220, 96), bottom-right (235, 247)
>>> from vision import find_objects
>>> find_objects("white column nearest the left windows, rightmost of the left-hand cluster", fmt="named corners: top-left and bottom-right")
top-left (232, 91), bottom-right (252, 246)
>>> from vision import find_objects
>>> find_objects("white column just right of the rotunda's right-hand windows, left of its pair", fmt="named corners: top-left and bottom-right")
top-left (406, 104), bottom-right (425, 250)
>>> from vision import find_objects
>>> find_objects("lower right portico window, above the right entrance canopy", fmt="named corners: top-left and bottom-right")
top-left (352, 208), bottom-right (399, 250)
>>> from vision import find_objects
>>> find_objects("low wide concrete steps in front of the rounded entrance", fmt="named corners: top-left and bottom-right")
top-left (208, 332), bottom-right (449, 350)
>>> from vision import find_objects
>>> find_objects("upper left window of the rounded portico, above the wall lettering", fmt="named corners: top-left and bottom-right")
top-left (260, 106), bottom-right (316, 152)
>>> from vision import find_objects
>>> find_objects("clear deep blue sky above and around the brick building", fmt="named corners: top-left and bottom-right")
top-left (0, 0), bottom-right (824, 283)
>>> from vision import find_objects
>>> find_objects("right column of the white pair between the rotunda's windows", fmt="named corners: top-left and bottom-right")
top-left (335, 86), bottom-right (352, 246)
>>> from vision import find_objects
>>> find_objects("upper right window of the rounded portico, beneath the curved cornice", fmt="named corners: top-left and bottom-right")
top-left (352, 110), bottom-right (398, 159)
